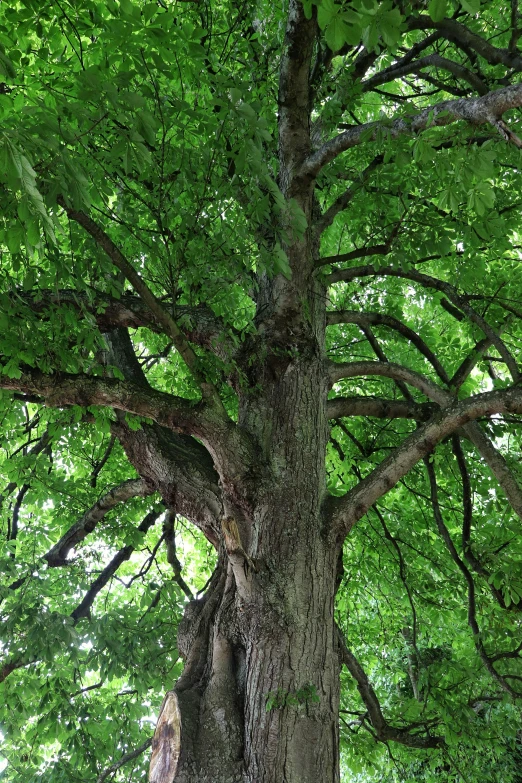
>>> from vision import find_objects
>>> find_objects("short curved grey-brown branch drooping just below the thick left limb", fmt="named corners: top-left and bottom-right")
top-left (44, 479), bottom-right (154, 567)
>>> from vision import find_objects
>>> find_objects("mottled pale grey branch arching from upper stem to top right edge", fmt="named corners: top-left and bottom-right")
top-left (300, 84), bottom-right (522, 178)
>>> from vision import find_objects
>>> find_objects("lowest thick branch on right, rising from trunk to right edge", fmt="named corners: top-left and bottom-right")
top-left (330, 387), bottom-right (522, 538)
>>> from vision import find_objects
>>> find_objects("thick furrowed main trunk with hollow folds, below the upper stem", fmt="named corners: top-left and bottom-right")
top-left (150, 324), bottom-right (339, 783)
